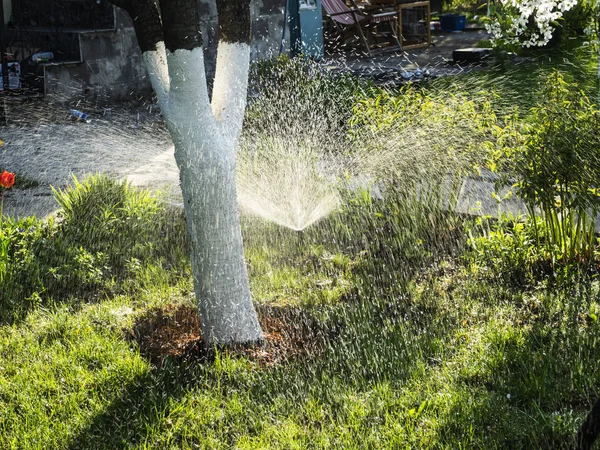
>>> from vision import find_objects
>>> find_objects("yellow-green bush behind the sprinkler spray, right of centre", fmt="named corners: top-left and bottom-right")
top-left (350, 85), bottom-right (497, 192)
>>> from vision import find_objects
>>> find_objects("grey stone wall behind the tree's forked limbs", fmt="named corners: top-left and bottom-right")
top-left (45, 0), bottom-right (289, 102)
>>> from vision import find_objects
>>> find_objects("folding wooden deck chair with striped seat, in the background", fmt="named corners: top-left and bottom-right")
top-left (322, 0), bottom-right (401, 56)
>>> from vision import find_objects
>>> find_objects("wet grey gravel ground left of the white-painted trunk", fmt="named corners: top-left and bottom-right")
top-left (0, 103), bottom-right (181, 221)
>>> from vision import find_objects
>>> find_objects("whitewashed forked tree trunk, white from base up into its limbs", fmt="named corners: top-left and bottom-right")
top-left (111, 0), bottom-right (263, 345)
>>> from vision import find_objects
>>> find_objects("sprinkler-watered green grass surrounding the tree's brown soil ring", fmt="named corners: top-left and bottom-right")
top-left (0, 178), bottom-right (600, 449)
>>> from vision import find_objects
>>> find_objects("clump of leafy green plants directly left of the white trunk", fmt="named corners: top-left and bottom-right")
top-left (0, 175), bottom-right (188, 321)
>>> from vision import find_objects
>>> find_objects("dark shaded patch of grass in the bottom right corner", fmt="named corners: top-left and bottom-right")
top-left (437, 287), bottom-right (600, 449)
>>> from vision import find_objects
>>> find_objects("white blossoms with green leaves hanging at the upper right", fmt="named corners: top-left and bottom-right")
top-left (487, 0), bottom-right (577, 47)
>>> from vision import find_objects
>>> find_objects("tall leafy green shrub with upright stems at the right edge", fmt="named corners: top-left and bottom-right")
top-left (499, 71), bottom-right (600, 264)
